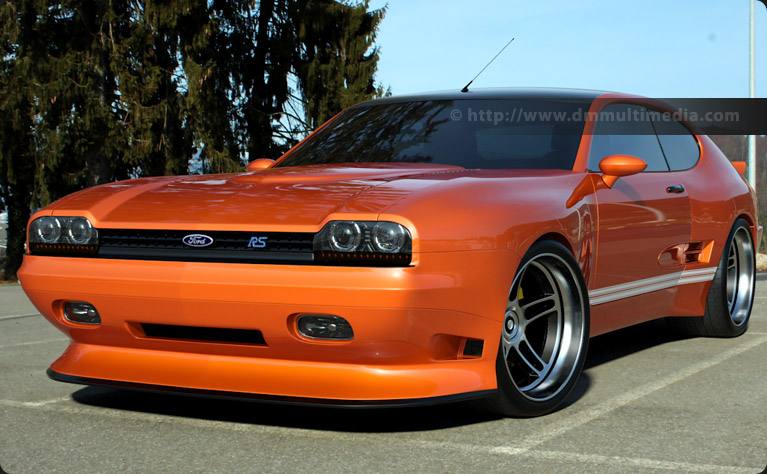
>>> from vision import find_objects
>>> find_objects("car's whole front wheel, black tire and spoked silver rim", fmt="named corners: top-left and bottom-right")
top-left (486, 241), bottom-right (589, 417)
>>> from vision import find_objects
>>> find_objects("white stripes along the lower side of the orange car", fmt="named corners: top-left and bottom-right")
top-left (589, 267), bottom-right (716, 306)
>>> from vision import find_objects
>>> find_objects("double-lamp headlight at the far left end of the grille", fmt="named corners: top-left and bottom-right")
top-left (29, 216), bottom-right (99, 257)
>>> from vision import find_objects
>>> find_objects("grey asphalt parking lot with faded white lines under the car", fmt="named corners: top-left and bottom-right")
top-left (0, 280), bottom-right (767, 474)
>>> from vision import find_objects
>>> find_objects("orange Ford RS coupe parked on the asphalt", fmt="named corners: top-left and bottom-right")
top-left (19, 89), bottom-right (762, 416)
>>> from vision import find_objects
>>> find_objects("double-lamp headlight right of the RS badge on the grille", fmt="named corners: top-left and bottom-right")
top-left (314, 221), bottom-right (412, 266)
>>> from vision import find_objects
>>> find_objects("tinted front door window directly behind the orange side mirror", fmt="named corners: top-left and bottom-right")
top-left (589, 104), bottom-right (669, 172)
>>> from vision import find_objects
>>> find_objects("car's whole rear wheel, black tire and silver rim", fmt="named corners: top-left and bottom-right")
top-left (668, 219), bottom-right (756, 337)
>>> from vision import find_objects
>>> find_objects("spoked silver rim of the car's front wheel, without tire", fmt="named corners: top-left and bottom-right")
top-left (501, 254), bottom-right (588, 401)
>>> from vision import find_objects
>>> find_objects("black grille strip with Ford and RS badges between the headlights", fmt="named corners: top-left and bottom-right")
top-left (98, 229), bottom-right (314, 263)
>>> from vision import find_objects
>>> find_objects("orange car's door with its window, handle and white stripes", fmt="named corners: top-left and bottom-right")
top-left (589, 104), bottom-right (690, 308)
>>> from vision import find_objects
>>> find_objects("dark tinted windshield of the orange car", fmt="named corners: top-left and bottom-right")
top-left (277, 99), bottom-right (591, 170)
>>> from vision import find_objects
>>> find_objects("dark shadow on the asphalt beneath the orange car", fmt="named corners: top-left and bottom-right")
top-left (72, 320), bottom-right (680, 433)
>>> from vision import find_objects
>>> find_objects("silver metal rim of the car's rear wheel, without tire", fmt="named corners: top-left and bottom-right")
top-left (726, 227), bottom-right (755, 326)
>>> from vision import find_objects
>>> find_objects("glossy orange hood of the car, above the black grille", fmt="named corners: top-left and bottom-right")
top-left (51, 163), bottom-right (462, 230)
